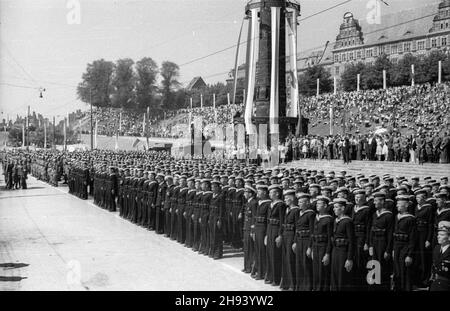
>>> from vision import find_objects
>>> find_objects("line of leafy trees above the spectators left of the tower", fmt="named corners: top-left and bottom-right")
top-left (77, 57), bottom-right (236, 113)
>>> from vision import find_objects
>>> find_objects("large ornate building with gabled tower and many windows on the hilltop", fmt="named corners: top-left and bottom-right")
top-left (297, 0), bottom-right (450, 78)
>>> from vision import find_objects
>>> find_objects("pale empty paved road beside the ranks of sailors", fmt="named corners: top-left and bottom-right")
top-left (0, 175), bottom-right (278, 291)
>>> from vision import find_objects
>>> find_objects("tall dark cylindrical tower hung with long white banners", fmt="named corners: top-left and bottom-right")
top-left (244, 0), bottom-right (300, 145)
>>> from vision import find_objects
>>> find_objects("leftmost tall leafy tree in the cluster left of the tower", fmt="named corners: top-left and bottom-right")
top-left (77, 59), bottom-right (114, 107)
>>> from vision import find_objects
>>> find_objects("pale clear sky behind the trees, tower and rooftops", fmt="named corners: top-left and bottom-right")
top-left (0, 0), bottom-right (439, 120)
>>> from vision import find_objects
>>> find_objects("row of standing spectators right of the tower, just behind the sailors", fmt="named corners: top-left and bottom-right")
top-left (284, 131), bottom-right (450, 164)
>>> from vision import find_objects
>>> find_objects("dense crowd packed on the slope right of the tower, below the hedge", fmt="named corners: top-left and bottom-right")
top-left (300, 82), bottom-right (450, 132)
